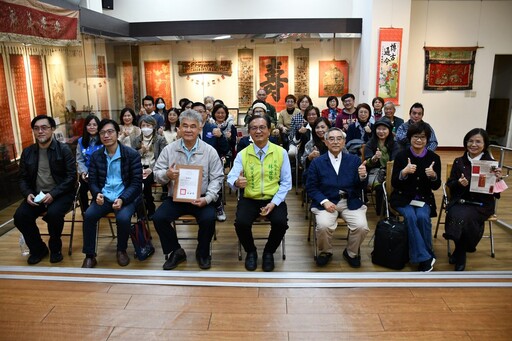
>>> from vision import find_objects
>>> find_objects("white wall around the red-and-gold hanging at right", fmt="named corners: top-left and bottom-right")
top-left (402, 0), bottom-right (512, 147)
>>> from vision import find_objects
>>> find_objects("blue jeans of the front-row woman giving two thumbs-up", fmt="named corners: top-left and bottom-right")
top-left (396, 204), bottom-right (434, 263)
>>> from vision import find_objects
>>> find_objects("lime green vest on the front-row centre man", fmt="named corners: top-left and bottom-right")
top-left (241, 143), bottom-right (283, 200)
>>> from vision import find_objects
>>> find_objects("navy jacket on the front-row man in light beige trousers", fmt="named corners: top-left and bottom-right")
top-left (306, 153), bottom-right (368, 210)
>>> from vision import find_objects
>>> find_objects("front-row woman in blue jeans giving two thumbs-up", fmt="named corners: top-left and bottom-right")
top-left (390, 122), bottom-right (441, 272)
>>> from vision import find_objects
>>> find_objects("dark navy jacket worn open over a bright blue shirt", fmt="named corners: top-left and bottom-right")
top-left (89, 143), bottom-right (142, 204)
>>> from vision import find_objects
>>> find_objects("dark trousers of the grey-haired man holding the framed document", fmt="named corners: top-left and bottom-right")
top-left (153, 197), bottom-right (216, 257)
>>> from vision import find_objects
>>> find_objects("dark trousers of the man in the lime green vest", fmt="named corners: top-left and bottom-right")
top-left (235, 198), bottom-right (288, 253)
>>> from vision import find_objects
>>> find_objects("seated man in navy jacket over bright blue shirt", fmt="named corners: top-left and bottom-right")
top-left (82, 119), bottom-right (142, 268)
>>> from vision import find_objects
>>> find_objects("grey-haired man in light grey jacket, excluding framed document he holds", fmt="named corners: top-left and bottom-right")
top-left (153, 110), bottom-right (224, 270)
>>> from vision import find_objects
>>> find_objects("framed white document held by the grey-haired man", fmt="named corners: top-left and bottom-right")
top-left (173, 165), bottom-right (203, 202)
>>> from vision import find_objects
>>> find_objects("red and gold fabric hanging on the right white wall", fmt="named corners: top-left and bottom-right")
top-left (423, 46), bottom-right (477, 91)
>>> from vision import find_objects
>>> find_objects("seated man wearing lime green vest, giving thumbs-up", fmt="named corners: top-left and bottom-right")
top-left (228, 115), bottom-right (292, 271)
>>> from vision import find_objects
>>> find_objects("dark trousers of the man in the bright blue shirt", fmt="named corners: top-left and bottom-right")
top-left (82, 199), bottom-right (140, 255)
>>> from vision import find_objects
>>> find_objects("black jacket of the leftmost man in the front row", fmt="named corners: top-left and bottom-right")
top-left (19, 139), bottom-right (76, 199)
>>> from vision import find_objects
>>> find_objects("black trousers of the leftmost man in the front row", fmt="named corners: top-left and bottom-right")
top-left (14, 193), bottom-right (73, 255)
